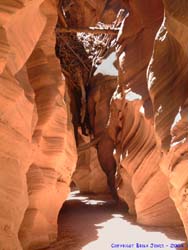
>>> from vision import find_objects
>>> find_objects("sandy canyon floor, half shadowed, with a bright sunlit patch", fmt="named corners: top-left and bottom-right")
top-left (43, 191), bottom-right (186, 250)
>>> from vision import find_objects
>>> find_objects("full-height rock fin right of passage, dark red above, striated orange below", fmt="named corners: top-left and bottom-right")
top-left (108, 0), bottom-right (181, 226)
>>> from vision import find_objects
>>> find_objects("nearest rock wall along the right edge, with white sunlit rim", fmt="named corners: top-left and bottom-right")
top-left (148, 0), bottom-right (188, 238)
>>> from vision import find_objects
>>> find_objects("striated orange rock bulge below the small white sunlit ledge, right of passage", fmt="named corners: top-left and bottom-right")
top-left (108, 89), bottom-right (181, 226)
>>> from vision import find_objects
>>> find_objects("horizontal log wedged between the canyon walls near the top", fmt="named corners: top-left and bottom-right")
top-left (56, 27), bottom-right (119, 36)
